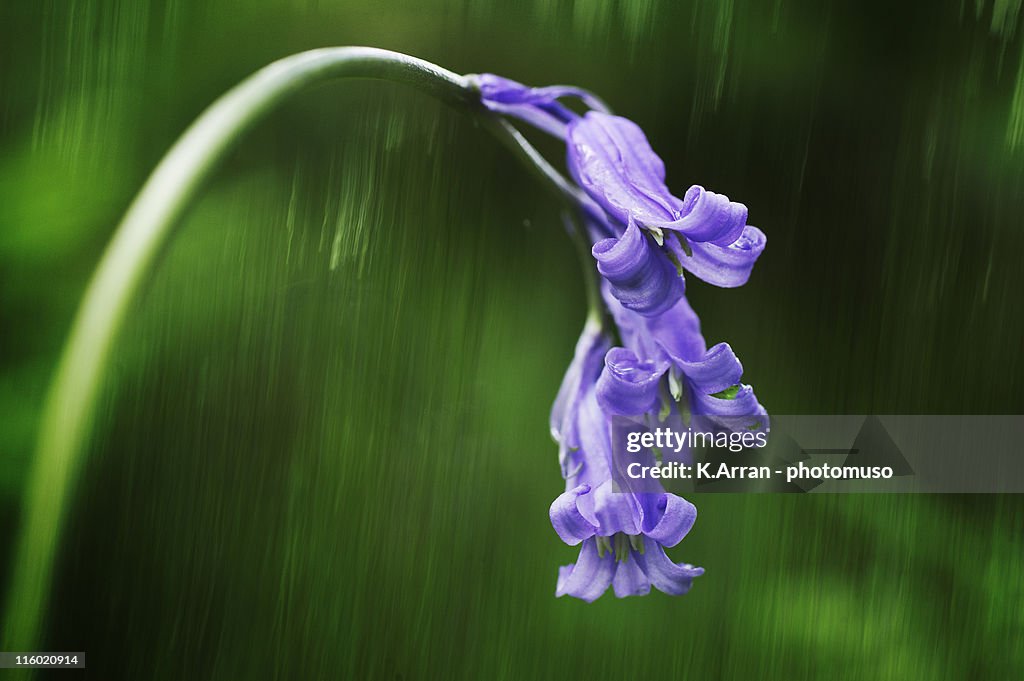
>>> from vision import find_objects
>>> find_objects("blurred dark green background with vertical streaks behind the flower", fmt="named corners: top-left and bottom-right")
top-left (0, 0), bottom-right (1024, 680)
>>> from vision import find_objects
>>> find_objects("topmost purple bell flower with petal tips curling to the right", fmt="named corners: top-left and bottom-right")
top-left (566, 112), bottom-right (765, 288)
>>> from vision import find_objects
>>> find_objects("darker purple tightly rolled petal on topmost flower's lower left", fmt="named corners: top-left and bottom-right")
top-left (592, 217), bottom-right (685, 316)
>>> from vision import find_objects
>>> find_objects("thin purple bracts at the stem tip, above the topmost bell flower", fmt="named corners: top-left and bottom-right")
top-left (475, 74), bottom-right (607, 139)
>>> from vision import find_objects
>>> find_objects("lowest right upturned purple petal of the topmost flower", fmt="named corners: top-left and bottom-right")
top-left (666, 225), bottom-right (767, 289)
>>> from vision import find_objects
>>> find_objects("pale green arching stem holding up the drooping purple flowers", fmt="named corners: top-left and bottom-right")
top-left (0, 47), bottom-right (590, 650)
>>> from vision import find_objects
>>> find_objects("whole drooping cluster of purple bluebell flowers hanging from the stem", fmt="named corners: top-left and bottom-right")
top-left (476, 75), bottom-right (767, 601)
